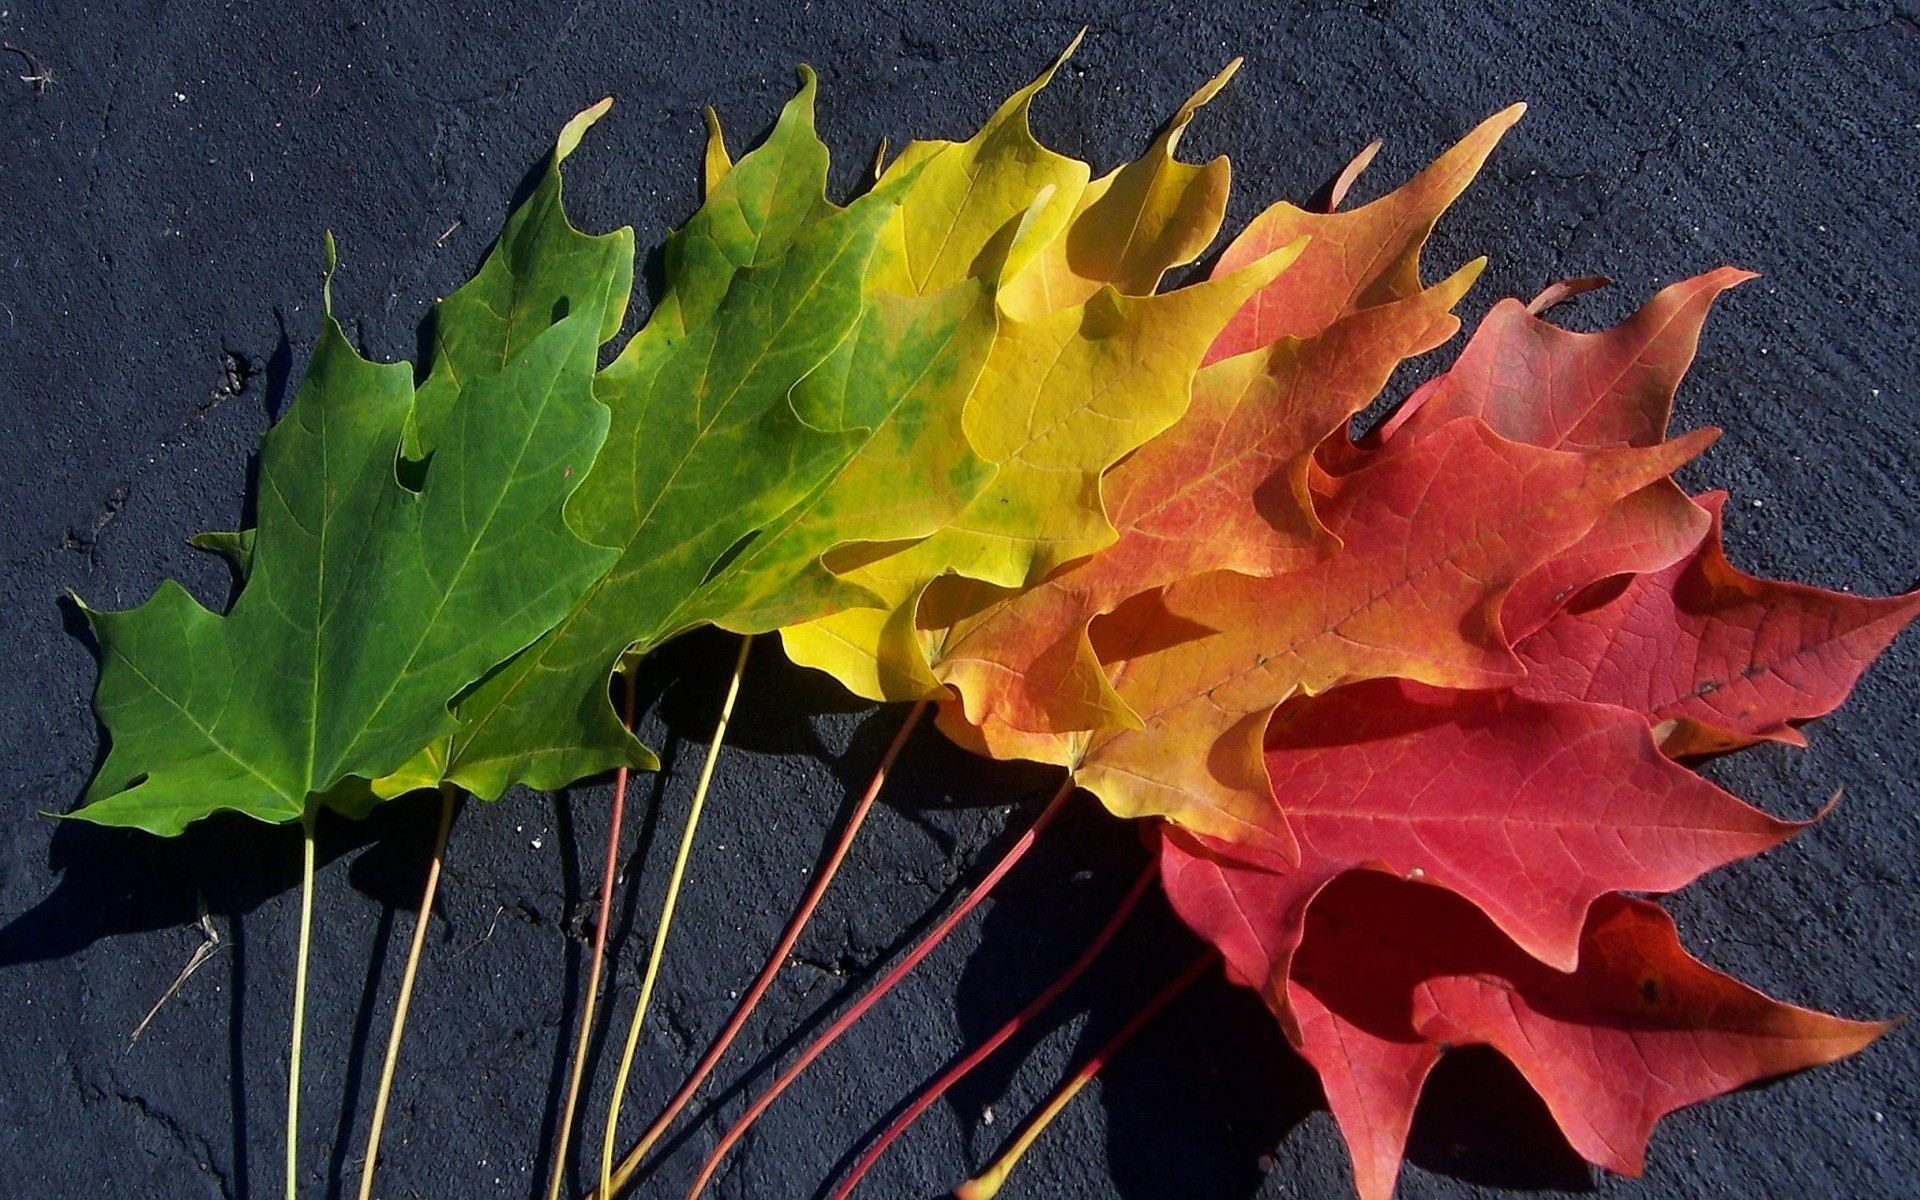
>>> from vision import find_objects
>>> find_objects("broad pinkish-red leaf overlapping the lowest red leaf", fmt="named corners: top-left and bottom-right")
top-left (1167, 680), bottom-right (1803, 977)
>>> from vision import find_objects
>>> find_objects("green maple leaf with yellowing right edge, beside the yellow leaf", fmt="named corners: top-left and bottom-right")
top-left (439, 73), bottom-right (995, 797)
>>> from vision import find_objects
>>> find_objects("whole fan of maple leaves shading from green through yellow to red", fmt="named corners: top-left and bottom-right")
top-left (75, 32), bottom-right (1920, 1198)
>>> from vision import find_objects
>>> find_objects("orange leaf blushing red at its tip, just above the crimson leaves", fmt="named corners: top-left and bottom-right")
top-left (981, 419), bottom-right (1711, 858)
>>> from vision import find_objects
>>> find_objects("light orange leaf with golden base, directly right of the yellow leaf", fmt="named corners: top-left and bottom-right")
top-left (924, 255), bottom-right (1480, 733)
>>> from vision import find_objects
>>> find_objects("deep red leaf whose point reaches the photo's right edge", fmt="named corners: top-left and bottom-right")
top-left (1519, 492), bottom-right (1920, 756)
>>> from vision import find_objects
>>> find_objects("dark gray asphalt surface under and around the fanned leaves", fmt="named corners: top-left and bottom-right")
top-left (0, 0), bottom-right (1920, 1200)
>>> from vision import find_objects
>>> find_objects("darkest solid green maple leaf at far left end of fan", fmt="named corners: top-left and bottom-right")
top-left (73, 106), bottom-right (632, 835)
